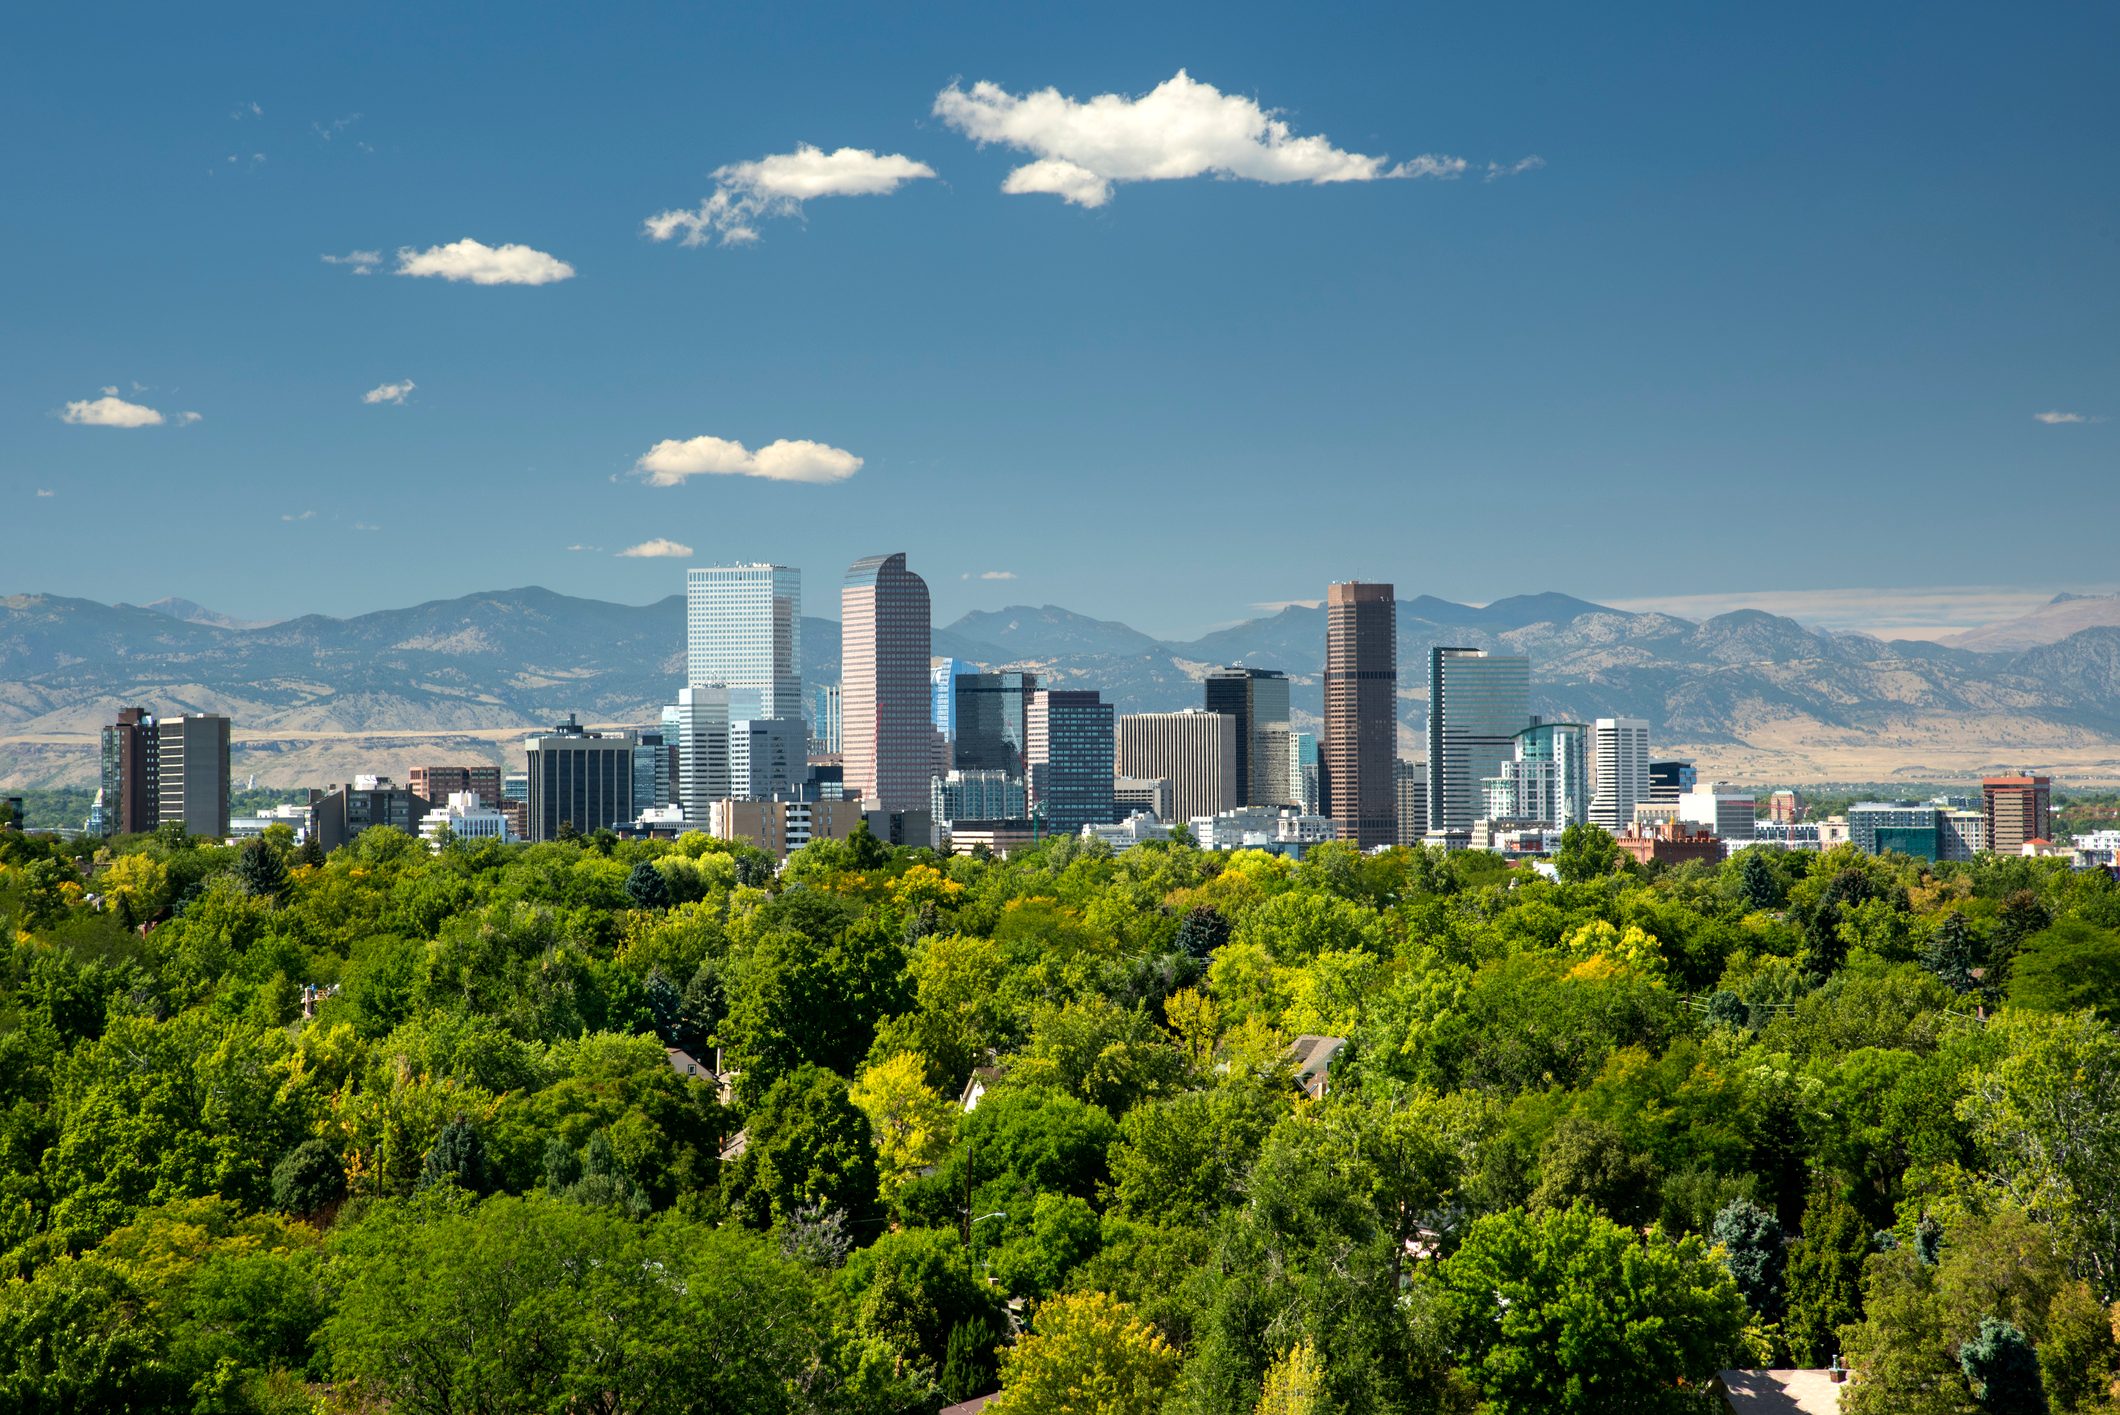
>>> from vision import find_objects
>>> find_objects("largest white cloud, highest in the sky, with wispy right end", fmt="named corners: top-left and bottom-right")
top-left (935, 70), bottom-right (1467, 206)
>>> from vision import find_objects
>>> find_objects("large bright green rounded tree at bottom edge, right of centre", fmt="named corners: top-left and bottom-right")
top-left (1435, 1205), bottom-right (1745, 1415)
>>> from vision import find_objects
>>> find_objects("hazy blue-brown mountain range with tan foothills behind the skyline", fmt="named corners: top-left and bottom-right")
top-left (0, 588), bottom-right (2120, 787)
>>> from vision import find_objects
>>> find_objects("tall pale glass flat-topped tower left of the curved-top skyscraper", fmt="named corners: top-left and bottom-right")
top-left (685, 564), bottom-right (801, 721)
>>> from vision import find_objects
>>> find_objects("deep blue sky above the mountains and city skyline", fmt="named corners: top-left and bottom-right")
top-left (0, 4), bottom-right (2120, 634)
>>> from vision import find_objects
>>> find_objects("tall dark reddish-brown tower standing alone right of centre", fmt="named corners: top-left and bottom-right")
top-left (1319, 579), bottom-right (1399, 851)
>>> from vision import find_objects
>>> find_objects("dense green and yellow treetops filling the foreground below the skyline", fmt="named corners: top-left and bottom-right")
top-left (0, 827), bottom-right (2120, 1415)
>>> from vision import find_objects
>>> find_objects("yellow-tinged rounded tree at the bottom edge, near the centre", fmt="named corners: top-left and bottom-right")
top-left (986, 1292), bottom-right (1179, 1415)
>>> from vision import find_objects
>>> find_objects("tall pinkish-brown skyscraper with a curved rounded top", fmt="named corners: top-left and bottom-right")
top-left (840, 552), bottom-right (935, 813)
